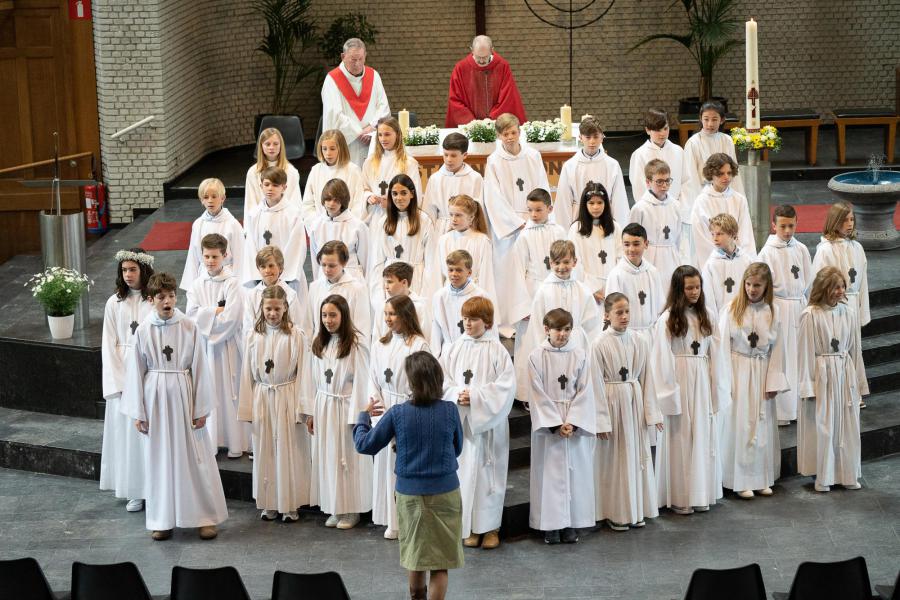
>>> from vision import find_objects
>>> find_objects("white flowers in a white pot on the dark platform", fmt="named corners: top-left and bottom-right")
top-left (25, 267), bottom-right (94, 340)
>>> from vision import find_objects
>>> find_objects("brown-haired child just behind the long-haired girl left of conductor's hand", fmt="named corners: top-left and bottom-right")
top-left (307, 240), bottom-right (372, 342)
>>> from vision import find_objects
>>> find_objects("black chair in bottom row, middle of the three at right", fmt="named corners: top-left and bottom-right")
top-left (776, 556), bottom-right (872, 600)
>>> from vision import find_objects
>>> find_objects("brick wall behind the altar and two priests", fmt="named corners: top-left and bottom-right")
top-left (93, 0), bottom-right (900, 222)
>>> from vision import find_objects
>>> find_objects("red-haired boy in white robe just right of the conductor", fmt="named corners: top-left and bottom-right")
top-left (441, 297), bottom-right (516, 550)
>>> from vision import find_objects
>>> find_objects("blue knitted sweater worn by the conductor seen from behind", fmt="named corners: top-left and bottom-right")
top-left (353, 401), bottom-right (463, 496)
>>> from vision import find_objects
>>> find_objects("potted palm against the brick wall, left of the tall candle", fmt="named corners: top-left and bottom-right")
top-left (628, 0), bottom-right (741, 114)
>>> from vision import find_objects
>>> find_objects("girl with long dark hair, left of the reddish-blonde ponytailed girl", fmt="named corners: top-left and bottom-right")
top-left (366, 174), bottom-right (441, 301)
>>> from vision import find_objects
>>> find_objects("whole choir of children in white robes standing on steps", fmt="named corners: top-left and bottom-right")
top-left (100, 103), bottom-right (869, 548)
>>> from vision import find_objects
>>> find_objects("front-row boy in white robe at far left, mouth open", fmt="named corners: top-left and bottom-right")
top-left (122, 273), bottom-right (228, 541)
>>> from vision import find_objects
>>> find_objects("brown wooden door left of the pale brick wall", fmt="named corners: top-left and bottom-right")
top-left (0, 0), bottom-right (100, 263)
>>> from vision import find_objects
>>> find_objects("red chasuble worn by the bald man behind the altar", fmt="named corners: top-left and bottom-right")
top-left (445, 52), bottom-right (526, 127)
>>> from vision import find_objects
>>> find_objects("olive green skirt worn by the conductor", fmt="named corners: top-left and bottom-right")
top-left (395, 488), bottom-right (464, 571)
